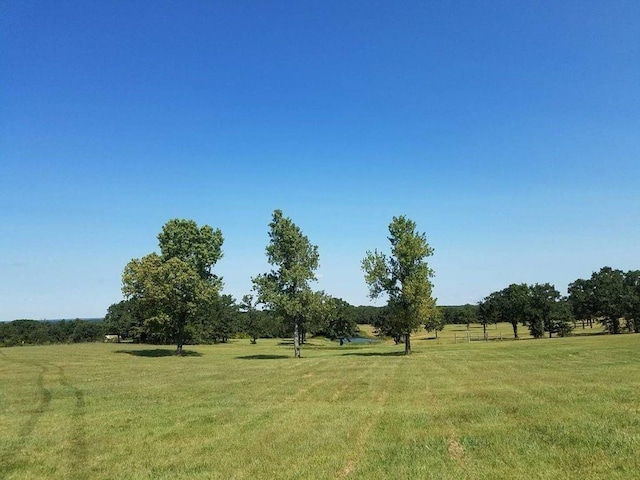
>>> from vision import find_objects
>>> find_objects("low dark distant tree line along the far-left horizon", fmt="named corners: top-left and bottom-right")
top-left (0, 318), bottom-right (105, 347)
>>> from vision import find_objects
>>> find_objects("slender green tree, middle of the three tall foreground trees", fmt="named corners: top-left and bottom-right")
top-left (252, 210), bottom-right (320, 358)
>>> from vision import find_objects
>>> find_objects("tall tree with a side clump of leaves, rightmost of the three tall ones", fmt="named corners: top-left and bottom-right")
top-left (362, 215), bottom-right (436, 354)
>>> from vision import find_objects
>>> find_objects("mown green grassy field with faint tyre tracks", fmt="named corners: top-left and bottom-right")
top-left (0, 325), bottom-right (640, 479)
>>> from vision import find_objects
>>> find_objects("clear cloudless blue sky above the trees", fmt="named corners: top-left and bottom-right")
top-left (0, 0), bottom-right (640, 320)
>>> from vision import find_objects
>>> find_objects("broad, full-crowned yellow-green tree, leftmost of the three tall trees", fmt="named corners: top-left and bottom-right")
top-left (122, 219), bottom-right (223, 355)
